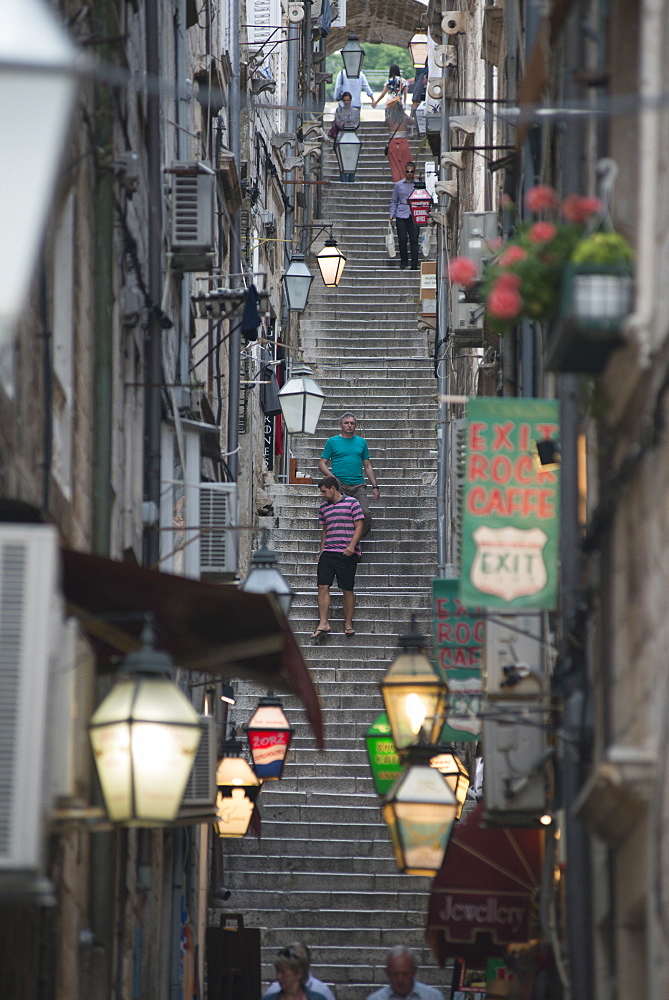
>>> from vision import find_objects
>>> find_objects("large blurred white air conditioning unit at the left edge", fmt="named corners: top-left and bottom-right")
top-left (0, 524), bottom-right (62, 880)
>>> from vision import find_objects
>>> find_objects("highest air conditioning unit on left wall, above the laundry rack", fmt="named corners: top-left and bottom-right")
top-left (169, 162), bottom-right (216, 271)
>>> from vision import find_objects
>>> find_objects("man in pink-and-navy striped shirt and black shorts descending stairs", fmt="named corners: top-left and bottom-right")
top-left (311, 476), bottom-right (365, 642)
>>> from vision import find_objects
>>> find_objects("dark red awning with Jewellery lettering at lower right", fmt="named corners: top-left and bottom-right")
top-left (427, 802), bottom-right (543, 966)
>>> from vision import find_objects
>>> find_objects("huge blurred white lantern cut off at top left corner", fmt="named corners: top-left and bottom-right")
top-left (0, 0), bottom-right (77, 346)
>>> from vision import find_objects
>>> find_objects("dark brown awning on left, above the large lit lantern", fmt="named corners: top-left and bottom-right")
top-left (62, 549), bottom-right (323, 747)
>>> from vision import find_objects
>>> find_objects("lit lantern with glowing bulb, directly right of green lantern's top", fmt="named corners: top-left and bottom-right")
top-left (381, 616), bottom-right (446, 756)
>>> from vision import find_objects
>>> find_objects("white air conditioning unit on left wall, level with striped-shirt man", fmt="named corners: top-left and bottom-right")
top-left (199, 483), bottom-right (238, 579)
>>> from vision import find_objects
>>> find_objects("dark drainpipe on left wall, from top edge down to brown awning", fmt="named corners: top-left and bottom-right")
top-left (143, 0), bottom-right (163, 566)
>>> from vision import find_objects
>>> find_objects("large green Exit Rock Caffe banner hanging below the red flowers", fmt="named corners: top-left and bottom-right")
top-left (460, 397), bottom-right (560, 610)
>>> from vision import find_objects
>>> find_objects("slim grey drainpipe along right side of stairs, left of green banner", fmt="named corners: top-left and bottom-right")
top-left (435, 90), bottom-right (451, 577)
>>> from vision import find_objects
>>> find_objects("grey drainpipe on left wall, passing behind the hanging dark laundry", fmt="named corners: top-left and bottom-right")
top-left (227, 3), bottom-right (242, 481)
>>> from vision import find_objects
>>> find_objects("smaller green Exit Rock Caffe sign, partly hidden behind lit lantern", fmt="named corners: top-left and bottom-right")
top-left (432, 579), bottom-right (485, 743)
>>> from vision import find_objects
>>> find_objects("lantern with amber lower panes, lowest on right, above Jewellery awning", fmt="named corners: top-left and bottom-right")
top-left (381, 746), bottom-right (458, 876)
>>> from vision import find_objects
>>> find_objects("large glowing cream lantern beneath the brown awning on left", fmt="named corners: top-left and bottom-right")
top-left (88, 624), bottom-right (202, 826)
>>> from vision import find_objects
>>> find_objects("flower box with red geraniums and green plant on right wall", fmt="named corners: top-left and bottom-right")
top-left (449, 185), bottom-right (633, 372)
